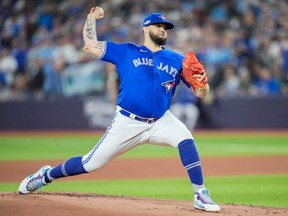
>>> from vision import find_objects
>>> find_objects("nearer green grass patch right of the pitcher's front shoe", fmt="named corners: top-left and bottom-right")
top-left (209, 174), bottom-right (288, 208)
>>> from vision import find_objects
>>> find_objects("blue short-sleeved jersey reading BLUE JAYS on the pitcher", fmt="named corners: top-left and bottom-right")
top-left (99, 42), bottom-right (184, 118)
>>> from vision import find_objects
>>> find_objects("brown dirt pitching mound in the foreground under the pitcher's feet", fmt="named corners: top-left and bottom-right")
top-left (0, 192), bottom-right (288, 216)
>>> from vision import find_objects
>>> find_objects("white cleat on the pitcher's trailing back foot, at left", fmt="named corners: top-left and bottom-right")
top-left (18, 165), bottom-right (52, 194)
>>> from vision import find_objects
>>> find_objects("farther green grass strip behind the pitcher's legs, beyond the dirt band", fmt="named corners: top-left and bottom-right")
top-left (0, 133), bottom-right (288, 161)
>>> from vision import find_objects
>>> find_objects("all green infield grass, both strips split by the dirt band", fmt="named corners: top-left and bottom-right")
top-left (0, 132), bottom-right (288, 208)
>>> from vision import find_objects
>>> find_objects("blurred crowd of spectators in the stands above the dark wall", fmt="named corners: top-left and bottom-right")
top-left (0, 0), bottom-right (288, 101)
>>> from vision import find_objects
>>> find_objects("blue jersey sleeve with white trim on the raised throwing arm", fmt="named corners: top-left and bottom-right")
top-left (99, 42), bottom-right (128, 65)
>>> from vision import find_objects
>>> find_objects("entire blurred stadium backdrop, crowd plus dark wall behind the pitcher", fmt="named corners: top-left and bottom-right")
top-left (0, 0), bottom-right (288, 130)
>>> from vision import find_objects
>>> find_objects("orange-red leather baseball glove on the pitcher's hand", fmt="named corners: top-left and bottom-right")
top-left (181, 52), bottom-right (208, 89)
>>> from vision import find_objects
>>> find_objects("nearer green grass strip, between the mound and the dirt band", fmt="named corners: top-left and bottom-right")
top-left (0, 175), bottom-right (288, 208)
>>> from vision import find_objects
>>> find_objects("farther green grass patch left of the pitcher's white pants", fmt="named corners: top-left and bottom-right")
top-left (0, 136), bottom-right (99, 161)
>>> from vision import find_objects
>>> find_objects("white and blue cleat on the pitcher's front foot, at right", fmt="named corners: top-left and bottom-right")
top-left (194, 188), bottom-right (220, 212)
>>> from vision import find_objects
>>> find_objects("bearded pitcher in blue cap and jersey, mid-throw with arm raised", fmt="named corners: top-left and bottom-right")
top-left (19, 7), bottom-right (220, 212)
